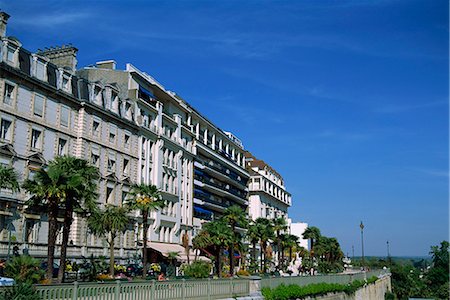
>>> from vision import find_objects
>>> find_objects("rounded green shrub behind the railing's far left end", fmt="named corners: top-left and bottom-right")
top-left (5, 255), bottom-right (45, 284)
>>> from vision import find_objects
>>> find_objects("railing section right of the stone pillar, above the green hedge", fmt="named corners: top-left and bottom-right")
top-left (261, 269), bottom-right (389, 288)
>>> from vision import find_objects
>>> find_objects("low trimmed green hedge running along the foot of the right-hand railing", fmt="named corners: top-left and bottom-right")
top-left (262, 276), bottom-right (378, 300)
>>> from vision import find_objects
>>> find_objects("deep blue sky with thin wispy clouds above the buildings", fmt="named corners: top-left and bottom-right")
top-left (0, 0), bottom-right (449, 255)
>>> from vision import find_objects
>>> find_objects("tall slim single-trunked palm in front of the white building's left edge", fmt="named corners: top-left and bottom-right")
top-left (125, 183), bottom-right (165, 276)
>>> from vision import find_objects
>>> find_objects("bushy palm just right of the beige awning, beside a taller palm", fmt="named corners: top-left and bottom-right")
top-left (202, 220), bottom-right (233, 277)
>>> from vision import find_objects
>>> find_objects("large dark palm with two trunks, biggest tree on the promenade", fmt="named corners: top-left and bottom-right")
top-left (23, 156), bottom-right (99, 282)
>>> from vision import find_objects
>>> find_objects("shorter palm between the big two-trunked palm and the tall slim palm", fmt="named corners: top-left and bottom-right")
top-left (88, 205), bottom-right (130, 276)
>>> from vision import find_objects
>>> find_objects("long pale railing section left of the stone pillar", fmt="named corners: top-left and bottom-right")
top-left (37, 279), bottom-right (250, 300)
